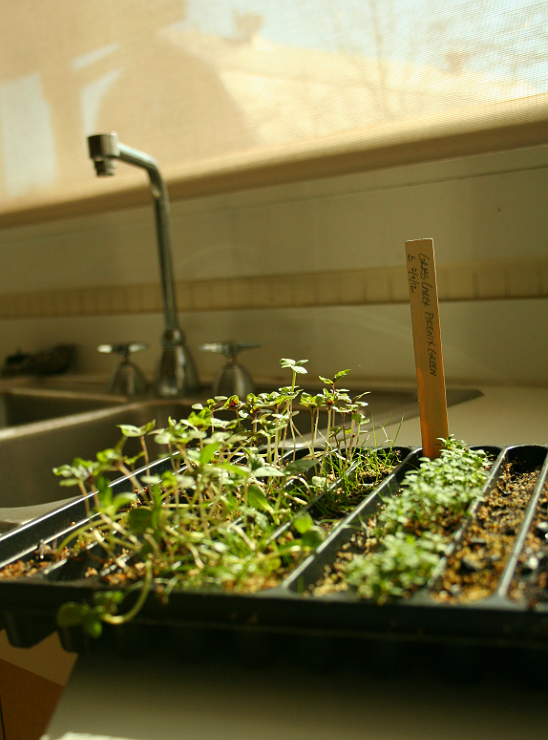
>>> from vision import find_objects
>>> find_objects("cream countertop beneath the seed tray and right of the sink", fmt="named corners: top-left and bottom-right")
top-left (5, 387), bottom-right (548, 740)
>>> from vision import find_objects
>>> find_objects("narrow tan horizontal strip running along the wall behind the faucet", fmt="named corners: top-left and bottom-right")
top-left (0, 257), bottom-right (548, 320)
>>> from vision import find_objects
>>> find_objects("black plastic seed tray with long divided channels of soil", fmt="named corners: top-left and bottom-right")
top-left (0, 445), bottom-right (548, 651)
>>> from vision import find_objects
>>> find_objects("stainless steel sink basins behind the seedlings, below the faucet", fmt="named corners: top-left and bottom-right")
top-left (0, 389), bottom-right (481, 532)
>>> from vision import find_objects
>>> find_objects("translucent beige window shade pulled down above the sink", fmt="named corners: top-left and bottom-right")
top-left (0, 0), bottom-right (548, 226)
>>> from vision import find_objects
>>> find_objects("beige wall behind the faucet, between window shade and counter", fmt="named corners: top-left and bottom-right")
top-left (0, 142), bottom-right (548, 385)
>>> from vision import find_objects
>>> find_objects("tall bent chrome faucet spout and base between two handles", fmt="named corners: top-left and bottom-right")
top-left (88, 133), bottom-right (199, 398)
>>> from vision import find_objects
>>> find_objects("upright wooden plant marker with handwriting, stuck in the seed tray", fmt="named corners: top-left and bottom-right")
top-left (405, 239), bottom-right (449, 460)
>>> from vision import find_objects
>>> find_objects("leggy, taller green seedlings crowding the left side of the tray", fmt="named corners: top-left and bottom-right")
top-left (55, 359), bottom-right (398, 636)
